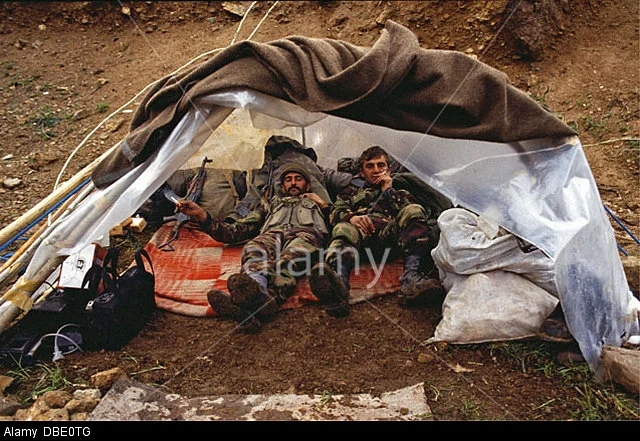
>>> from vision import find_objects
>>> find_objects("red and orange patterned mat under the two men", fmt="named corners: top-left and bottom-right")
top-left (145, 223), bottom-right (402, 317)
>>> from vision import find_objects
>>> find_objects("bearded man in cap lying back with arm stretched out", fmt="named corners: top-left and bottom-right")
top-left (178, 164), bottom-right (330, 332)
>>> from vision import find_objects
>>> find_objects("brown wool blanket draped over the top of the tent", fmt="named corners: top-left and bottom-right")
top-left (92, 21), bottom-right (575, 187)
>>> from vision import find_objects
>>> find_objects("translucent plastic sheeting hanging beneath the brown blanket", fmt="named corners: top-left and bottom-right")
top-left (17, 91), bottom-right (639, 378)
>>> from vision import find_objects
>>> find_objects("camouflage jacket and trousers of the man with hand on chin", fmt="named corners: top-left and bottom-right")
top-left (325, 180), bottom-right (437, 267)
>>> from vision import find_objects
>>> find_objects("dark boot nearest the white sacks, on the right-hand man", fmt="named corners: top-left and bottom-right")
top-left (398, 254), bottom-right (445, 307)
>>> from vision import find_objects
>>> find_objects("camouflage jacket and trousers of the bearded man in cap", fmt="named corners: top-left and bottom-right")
top-left (203, 196), bottom-right (329, 303)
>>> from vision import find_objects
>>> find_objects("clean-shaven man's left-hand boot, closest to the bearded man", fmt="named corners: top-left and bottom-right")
top-left (309, 262), bottom-right (351, 317)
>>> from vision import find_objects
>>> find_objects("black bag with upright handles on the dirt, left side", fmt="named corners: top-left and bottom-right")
top-left (83, 248), bottom-right (156, 350)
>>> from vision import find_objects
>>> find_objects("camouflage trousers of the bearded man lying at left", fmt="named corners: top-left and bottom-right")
top-left (241, 227), bottom-right (326, 302)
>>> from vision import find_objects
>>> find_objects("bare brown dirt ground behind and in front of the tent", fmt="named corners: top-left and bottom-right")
top-left (0, 0), bottom-right (640, 420)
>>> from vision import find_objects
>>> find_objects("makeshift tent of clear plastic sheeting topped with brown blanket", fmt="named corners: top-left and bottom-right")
top-left (2, 22), bottom-right (639, 378)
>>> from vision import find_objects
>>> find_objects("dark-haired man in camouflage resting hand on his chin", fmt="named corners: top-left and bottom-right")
top-left (309, 146), bottom-right (444, 317)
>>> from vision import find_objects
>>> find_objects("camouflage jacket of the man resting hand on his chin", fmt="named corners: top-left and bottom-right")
top-left (329, 179), bottom-right (417, 228)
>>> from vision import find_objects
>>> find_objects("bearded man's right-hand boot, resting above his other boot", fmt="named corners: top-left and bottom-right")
top-left (227, 273), bottom-right (280, 318)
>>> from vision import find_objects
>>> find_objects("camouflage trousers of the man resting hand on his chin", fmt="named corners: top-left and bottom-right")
top-left (325, 204), bottom-right (438, 268)
